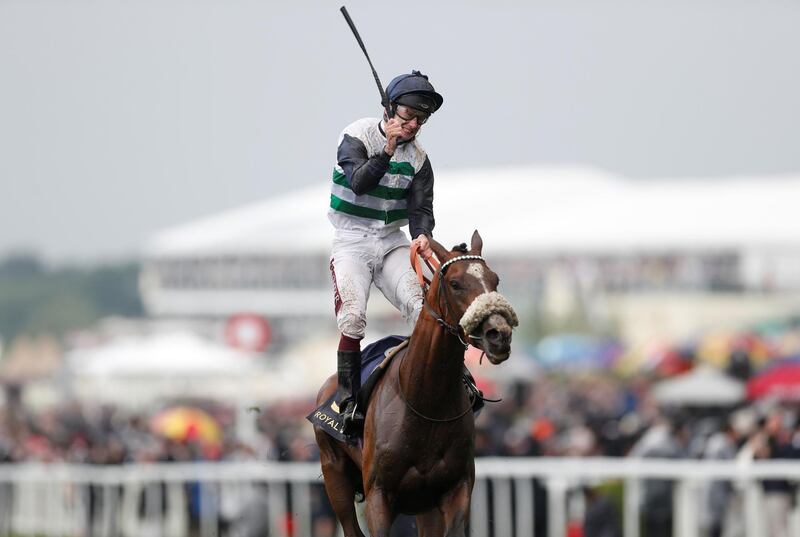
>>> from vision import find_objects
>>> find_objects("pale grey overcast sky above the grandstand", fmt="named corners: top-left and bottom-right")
top-left (0, 0), bottom-right (800, 261)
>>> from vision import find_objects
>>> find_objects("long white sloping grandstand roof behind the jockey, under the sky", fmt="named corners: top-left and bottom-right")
top-left (145, 167), bottom-right (800, 258)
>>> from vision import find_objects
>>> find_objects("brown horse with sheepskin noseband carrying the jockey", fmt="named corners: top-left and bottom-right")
top-left (314, 230), bottom-right (517, 537)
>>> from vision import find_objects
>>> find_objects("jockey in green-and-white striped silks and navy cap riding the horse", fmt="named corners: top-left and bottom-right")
top-left (328, 71), bottom-right (444, 435)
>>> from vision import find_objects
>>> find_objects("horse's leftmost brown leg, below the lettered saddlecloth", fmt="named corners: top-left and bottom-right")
top-left (317, 432), bottom-right (364, 537)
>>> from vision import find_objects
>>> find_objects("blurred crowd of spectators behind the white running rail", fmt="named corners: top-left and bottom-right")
top-left (0, 364), bottom-right (800, 537)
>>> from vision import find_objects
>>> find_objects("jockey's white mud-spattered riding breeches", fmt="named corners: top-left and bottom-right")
top-left (330, 230), bottom-right (423, 339)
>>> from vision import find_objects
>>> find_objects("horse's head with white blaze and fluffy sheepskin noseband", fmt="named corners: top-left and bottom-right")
top-left (426, 230), bottom-right (518, 364)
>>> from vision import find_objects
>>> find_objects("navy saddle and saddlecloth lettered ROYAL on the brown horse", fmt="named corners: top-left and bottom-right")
top-left (306, 336), bottom-right (487, 442)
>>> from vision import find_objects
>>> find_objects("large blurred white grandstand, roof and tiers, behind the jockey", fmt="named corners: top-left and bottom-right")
top-left (141, 167), bottom-right (800, 344)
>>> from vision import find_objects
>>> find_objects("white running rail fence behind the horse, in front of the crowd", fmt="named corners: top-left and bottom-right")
top-left (0, 458), bottom-right (800, 537)
